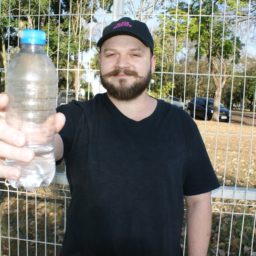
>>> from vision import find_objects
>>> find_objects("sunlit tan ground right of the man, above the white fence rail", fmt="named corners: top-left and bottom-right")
top-left (196, 118), bottom-right (256, 188)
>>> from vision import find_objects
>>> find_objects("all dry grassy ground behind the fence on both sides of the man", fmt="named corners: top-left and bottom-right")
top-left (0, 120), bottom-right (256, 256)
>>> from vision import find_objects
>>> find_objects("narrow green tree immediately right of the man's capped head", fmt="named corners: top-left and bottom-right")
top-left (154, 6), bottom-right (187, 98)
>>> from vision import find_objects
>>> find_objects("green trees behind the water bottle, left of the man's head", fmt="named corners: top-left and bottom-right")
top-left (0, 0), bottom-right (113, 92)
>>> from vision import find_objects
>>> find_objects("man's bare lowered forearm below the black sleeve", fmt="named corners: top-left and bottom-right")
top-left (187, 193), bottom-right (212, 256)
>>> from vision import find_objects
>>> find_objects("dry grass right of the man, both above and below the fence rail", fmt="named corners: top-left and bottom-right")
top-left (196, 120), bottom-right (256, 256)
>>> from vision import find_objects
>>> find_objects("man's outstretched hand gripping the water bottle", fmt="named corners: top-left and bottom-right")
top-left (0, 93), bottom-right (65, 179)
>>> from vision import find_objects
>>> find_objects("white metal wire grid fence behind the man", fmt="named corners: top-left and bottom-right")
top-left (0, 0), bottom-right (256, 256)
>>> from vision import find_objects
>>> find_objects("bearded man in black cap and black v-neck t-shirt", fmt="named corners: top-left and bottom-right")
top-left (0, 18), bottom-right (218, 256)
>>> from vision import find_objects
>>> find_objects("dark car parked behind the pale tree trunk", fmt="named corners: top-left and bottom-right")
top-left (187, 97), bottom-right (229, 122)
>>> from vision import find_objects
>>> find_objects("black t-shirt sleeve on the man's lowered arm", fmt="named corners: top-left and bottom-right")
top-left (183, 118), bottom-right (219, 196)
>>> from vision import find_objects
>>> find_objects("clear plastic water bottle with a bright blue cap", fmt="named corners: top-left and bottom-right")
top-left (5, 30), bottom-right (58, 191)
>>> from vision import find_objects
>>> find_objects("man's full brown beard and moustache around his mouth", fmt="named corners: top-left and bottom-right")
top-left (100, 69), bottom-right (151, 101)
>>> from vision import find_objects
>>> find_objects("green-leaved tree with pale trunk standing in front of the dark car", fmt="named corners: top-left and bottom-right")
top-left (157, 0), bottom-right (248, 120)
